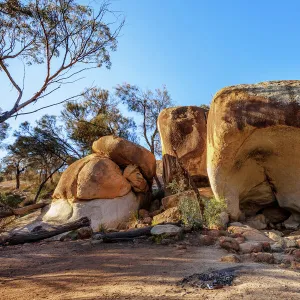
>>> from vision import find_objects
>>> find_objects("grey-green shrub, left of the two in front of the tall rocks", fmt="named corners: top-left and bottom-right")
top-left (178, 197), bottom-right (202, 229)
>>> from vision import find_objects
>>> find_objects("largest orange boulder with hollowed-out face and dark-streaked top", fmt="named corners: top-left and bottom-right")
top-left (207, 81), bottom-right (300, 221)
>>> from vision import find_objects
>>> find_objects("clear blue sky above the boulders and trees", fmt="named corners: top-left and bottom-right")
top-left (0, 0), bottom-right (300, 152)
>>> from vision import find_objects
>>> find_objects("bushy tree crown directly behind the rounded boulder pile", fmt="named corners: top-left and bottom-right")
top-left (62, 88), bottom-right (137, 155)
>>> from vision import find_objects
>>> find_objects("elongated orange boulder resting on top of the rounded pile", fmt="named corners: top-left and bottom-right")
top-left (92, 135), bottom-right (156, 182)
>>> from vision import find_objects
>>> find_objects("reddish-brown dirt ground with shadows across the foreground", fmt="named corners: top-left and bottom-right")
top-left (0, 240), bottom-right (300, 300)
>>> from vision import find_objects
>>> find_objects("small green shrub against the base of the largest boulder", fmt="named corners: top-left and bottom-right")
top-left (203, 198), bottom-right (227, 227)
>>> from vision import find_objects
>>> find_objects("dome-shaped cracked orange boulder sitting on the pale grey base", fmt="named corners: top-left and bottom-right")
top-left (53, 154), bottom-right (131, 200)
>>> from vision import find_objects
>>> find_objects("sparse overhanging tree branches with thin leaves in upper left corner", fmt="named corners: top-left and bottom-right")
top-left (0, 0), bottom-right (124, 123)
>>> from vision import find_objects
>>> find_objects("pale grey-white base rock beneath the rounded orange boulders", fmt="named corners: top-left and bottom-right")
top-left (43, 191), bottom-right (139, 231)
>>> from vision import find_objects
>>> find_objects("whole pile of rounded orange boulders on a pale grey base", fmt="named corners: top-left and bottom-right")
top-left (43, 136), bottom-right (156, 231)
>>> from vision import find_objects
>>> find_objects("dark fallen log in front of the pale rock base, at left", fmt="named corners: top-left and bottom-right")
top-left (0, 217), bottom-right (90, 245)
